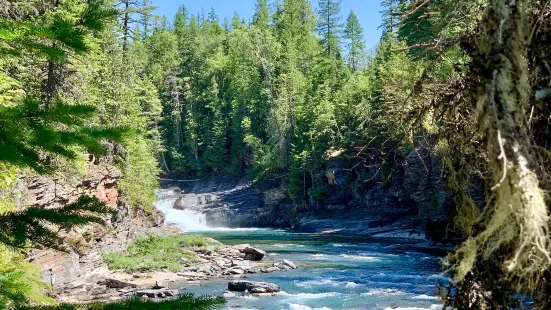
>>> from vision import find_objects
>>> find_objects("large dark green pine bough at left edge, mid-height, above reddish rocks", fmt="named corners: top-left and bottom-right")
top-left (0, 98), bottom-right (122, 173)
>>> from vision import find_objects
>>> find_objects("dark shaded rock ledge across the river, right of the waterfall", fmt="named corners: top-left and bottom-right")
top-left (162, 136), bottom-right (472, 243)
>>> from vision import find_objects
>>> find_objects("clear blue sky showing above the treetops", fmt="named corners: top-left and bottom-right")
top-left (153, 0), bottom-right (381, 48)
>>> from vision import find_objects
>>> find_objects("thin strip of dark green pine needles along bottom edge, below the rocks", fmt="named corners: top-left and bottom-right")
top-left (18, 294), bottom-right (225, 310)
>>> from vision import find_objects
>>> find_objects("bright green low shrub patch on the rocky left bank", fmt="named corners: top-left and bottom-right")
top-left (103, 235), bottom-right (210, 272)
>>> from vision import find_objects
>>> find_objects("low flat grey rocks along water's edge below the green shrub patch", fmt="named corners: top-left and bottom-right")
top-left (56, 232), bottom-right (297, 303)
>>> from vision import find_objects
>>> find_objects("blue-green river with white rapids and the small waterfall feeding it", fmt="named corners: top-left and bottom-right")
top-left (157, 190), bottom-right (447, 310)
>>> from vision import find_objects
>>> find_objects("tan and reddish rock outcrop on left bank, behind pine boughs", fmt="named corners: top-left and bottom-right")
top-left (20, 162), bottom-right (163, 301)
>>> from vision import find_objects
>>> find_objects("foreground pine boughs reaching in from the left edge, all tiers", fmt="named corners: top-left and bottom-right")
top-left (0, 1), bottom-right (123, 294)
